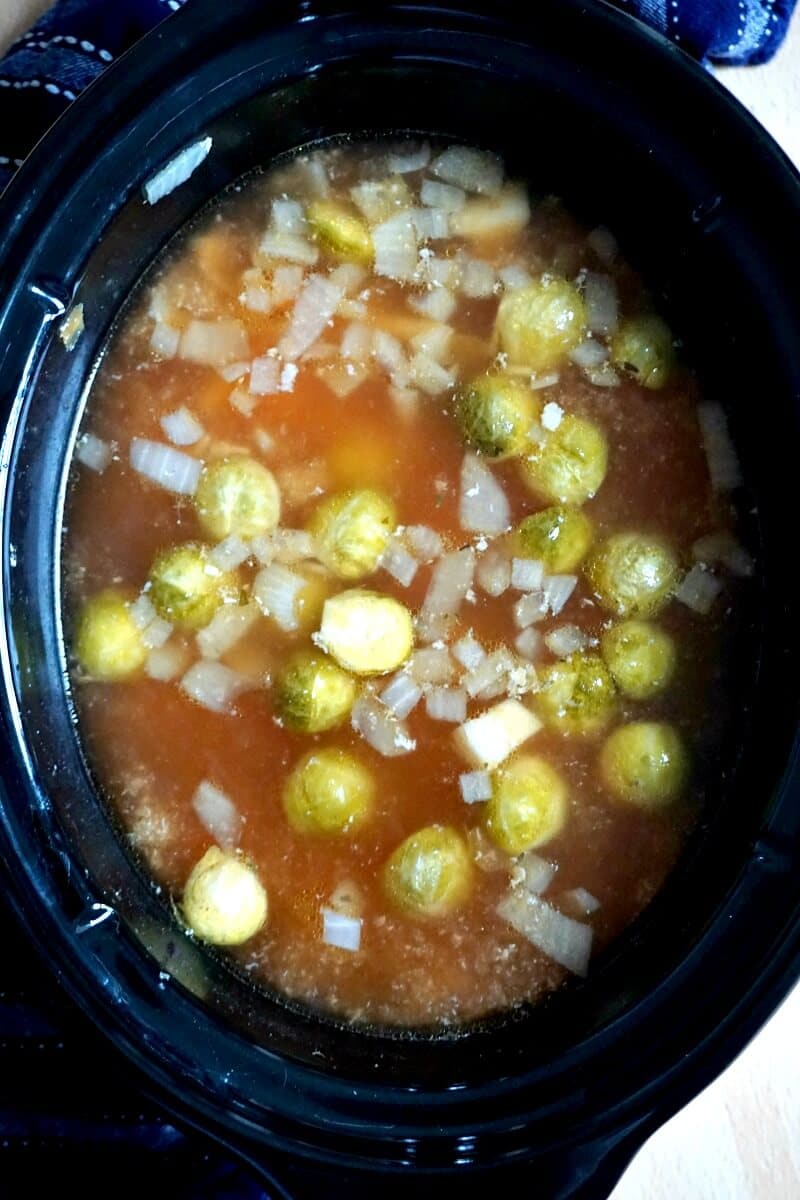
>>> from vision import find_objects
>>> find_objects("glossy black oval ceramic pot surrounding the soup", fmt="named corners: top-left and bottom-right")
top-left (0, 0), bottom-right (800, 1198)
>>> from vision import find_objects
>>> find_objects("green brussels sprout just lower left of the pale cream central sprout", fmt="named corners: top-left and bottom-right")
top-left (275, 650), bottom-right (356, 733)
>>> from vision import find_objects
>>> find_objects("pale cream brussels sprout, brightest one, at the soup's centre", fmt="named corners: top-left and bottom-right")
top-left (315, 588), bottom-right (414, 674)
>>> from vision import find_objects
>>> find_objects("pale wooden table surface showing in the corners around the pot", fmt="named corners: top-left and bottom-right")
top-left (0, 0), bottom-right (800, 1200)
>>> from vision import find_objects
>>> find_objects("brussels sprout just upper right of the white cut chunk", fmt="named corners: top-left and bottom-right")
top-left (536, 653), bottom-right (616, 734)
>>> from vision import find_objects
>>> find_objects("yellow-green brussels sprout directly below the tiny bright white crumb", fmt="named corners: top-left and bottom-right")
top-left (522, 414), bottom-right (608, 504)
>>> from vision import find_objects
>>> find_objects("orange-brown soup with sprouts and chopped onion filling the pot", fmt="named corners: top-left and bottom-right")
top-left (65, 144), bottom-right (752, 1025)
